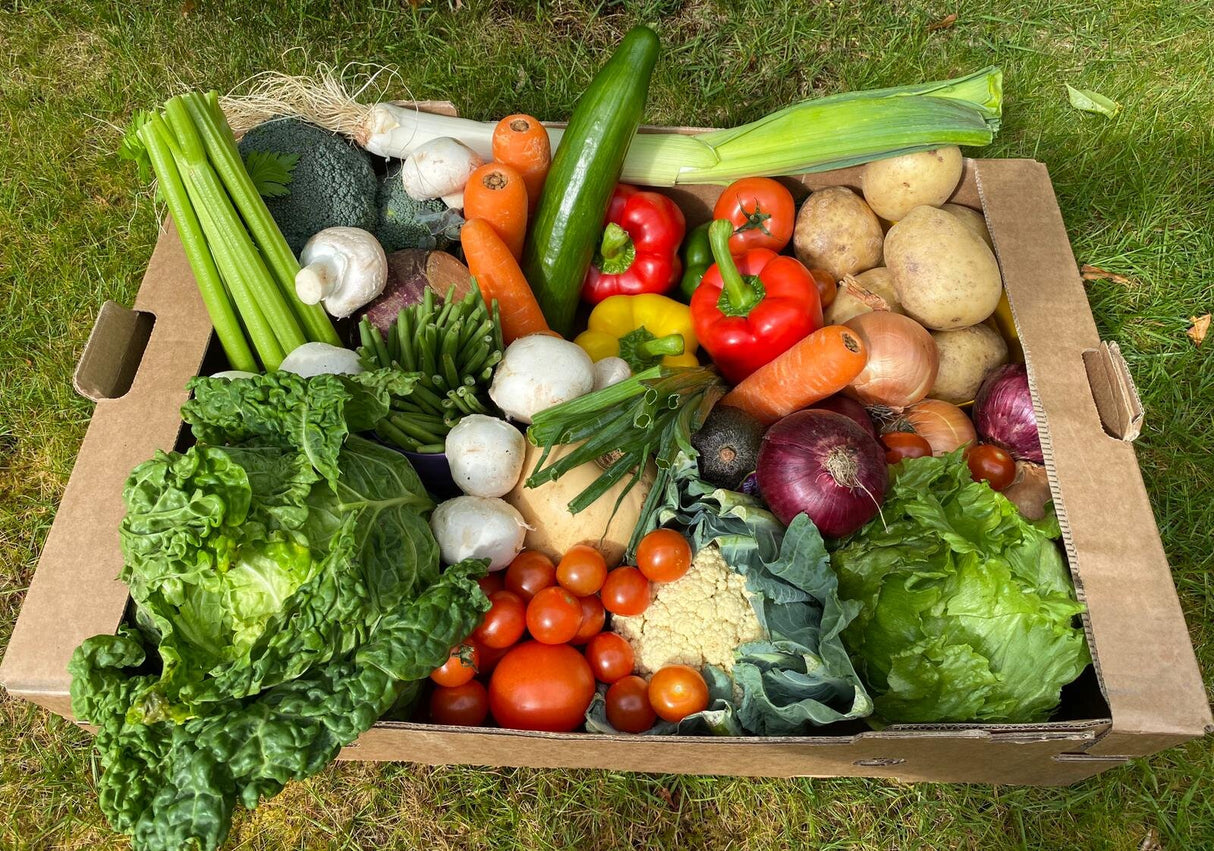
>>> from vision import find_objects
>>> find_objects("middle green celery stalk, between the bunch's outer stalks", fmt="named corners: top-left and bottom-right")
top-left (165, 97), bottom-right (307, 359)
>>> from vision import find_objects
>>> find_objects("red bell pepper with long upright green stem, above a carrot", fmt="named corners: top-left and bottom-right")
top-left (691, 219), bottom-right (822, 384)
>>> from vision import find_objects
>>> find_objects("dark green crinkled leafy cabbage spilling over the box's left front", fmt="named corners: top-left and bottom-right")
top-left (70, 373), bottom-right (488, 849)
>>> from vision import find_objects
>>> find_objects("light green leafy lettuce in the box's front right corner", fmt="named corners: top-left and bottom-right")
top-left (832, 452), bottom-right (1091, 724)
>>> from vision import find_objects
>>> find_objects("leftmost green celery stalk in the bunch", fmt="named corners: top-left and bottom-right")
top-left (138, 115), bottom-right (257, 373)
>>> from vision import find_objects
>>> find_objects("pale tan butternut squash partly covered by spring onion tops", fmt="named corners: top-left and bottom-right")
top-left (503, 443), bottom-right (657, 567)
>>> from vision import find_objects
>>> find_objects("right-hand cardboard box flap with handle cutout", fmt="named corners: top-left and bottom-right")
top-left (977, 160), bottom-right (1212, 756)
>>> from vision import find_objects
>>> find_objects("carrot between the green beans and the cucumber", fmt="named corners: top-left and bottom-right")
top-left (459, 219), bottom-right (548, 344)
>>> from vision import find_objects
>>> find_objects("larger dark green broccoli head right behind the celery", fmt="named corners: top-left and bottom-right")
top-left (239, 118), bottom-right (379, 255)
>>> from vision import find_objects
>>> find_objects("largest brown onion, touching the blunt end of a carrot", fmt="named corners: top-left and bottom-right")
top-left (844, 311), bottom-right (940, 408)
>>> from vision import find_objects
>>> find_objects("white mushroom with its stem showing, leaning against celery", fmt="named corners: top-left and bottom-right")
top-left (295, 227), bottom-right (387, 319)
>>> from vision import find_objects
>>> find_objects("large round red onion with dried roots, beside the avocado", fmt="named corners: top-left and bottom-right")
top-left (755, 410), bottom-right (889, 538)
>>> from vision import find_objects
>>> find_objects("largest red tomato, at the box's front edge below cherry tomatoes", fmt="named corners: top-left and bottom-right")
top-left (489, 641), bottom-right (595, 733)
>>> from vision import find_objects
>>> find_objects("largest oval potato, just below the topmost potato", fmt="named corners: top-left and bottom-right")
top-left (885, 206), bottom-right (1003, 331)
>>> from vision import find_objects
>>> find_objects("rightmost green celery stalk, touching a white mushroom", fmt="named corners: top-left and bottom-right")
top-left (185, 91), bottom-right (341, 346)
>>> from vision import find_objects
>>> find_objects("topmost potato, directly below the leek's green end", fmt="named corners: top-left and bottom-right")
top-left (860, 147), bottom-right (961, 222)
